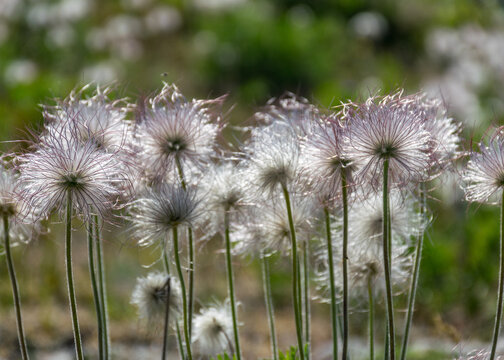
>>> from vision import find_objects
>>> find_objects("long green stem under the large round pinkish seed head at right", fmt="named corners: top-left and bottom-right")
top-left (382, 159), bottom-right (395, 360)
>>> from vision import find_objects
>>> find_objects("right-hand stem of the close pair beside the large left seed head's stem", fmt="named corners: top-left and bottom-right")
top-left (93, 215), bottom-right (110, 360)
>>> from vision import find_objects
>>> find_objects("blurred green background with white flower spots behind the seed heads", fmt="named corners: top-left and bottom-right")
top-left (0, 0), bottom-right (504, 358)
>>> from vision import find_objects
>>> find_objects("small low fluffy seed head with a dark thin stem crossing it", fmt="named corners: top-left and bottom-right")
top-left (131, 272), bottom-right (182, 324)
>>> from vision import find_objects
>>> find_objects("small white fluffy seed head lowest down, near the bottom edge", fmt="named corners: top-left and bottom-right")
top-left (193, 304), bottom-right (234, 356)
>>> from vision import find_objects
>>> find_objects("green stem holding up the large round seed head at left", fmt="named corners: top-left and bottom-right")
top-left (65, 190), bottom-right (84, 360)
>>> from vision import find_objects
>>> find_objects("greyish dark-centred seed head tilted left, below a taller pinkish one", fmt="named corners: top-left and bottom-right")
top-left (129, 183), bottom-right (201, 246)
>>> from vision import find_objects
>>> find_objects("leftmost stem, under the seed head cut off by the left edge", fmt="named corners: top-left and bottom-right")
top-left (3, 214), bottom-right (29, 360)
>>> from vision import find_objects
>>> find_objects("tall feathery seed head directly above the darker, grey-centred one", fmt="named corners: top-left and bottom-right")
top-left (136, 84), bottom-right (222, 178)
